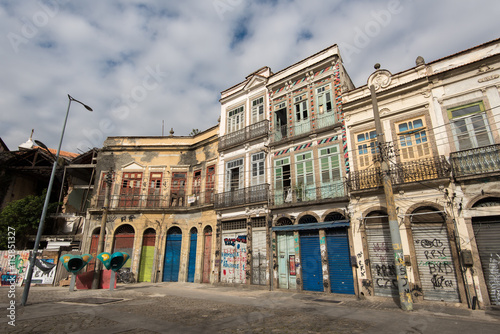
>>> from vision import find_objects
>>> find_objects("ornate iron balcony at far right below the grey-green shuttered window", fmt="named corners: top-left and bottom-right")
top-left (450, 144), bottom-right (500, 178)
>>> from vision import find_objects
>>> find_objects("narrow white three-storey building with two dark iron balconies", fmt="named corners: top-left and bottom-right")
top-left (214, 67), bottom-right (272, 285)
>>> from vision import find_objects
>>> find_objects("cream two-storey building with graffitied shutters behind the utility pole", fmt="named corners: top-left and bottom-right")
top-left (343, 40), bottom-right (500, 307)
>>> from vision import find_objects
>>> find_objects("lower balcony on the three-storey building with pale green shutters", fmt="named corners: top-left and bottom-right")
top-left (271, 181), bottom-right (346, 207)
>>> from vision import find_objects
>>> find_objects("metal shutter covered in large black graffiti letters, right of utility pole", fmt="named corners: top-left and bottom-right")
top-left (411, 223), bottom-right (460, 302)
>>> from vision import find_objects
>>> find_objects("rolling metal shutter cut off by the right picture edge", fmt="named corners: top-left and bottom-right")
top-left (473, 217), bottom-right (500, 305)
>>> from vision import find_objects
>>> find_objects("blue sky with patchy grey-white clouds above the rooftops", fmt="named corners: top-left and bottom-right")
top-left (0, 0), bottom-right (500, 153)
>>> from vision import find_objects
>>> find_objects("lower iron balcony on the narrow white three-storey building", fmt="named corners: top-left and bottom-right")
top-left (214, 184), bottom-right (269, 209)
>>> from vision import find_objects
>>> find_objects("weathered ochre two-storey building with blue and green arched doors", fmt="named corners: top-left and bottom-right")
top-left (82, 126), bottom-right (218, 283)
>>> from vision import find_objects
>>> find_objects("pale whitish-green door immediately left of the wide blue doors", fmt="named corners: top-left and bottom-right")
top-left (277, 232), bottom-right (297, 289)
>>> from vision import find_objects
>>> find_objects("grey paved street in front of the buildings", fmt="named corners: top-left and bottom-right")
top-left (0, 283), bottom-right (500, 334)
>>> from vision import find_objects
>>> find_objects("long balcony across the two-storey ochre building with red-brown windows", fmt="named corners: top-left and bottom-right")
top-left (92, 190), bottom-right (214, 210)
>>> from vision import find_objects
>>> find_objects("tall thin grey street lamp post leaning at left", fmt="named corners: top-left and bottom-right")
top-left (21, 94), bottom-right (93, 306)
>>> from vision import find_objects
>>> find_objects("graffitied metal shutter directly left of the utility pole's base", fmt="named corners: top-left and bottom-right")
top-left (366, 227), bottom-right (399, 297)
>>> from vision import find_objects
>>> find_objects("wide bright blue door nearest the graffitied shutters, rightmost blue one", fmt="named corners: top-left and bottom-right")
top-left (326, 228), bottom-right (354, 295)
